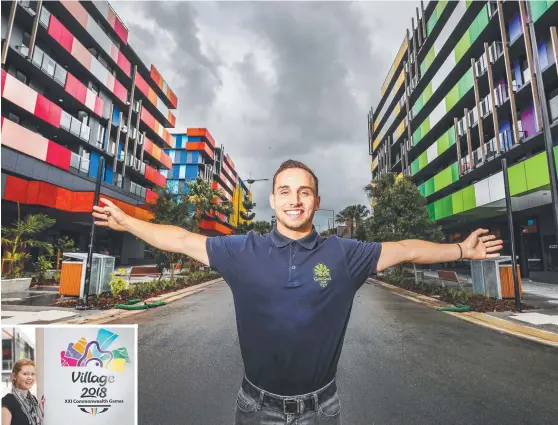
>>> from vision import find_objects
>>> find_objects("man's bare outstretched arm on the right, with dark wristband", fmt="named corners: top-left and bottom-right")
top-left (376, 229), bottom-right (503, 271)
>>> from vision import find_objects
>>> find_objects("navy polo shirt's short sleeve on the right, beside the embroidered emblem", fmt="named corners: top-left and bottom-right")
top-left (339, 238), bottom-right (382, 288)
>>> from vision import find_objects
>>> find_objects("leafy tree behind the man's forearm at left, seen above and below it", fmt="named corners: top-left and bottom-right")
top-left (148, 190), bottom-right (194, 281)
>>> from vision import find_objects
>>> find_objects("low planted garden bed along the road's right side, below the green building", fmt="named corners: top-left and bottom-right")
top-left (375, 271), bottom-right (536, 313)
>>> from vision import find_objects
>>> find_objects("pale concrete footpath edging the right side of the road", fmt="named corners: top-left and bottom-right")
top-left (368, 278), bottom-right (558, 347)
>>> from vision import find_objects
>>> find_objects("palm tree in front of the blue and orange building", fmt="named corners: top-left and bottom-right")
top-left (188, 178), bottom-right (232, 232)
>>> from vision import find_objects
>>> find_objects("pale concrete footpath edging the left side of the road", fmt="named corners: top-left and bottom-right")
top-left (2, 278), bottom-right (224, 325)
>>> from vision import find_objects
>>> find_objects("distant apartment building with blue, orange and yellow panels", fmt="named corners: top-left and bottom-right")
top-left (163, 128), bottom-right (252, 236)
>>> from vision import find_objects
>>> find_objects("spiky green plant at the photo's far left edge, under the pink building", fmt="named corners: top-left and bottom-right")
top-left (2, 208), bottom-right (56, 278)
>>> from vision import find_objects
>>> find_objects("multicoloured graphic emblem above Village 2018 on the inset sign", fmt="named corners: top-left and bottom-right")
top-left (60, 329), bottom-right (131, 373)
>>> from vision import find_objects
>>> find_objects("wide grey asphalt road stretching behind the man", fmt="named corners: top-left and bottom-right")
top-left (114, 283), bottom-right (558, 425)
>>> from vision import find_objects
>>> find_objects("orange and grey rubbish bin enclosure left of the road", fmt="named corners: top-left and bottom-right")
top-left (58, 252), bottom-right (115, 297)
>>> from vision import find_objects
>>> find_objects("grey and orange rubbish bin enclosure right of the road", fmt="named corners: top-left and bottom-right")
top-left (471, 256), bottom-right (523, 299)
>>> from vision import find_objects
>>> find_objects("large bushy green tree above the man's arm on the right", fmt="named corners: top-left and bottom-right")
top-left (368, 173), bottom-right (443, 248)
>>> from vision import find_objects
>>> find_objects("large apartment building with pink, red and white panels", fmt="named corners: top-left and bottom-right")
top-left (1, 1), bottom-right (178, 264)
